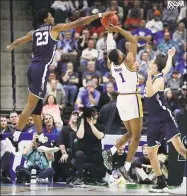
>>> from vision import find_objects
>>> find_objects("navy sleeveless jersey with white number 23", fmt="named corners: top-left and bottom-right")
top-left (32, 24), bottom-right (58, 64)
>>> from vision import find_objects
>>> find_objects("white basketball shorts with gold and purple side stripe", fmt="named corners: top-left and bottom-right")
top-left (116, 94), bottom-right (143, 121)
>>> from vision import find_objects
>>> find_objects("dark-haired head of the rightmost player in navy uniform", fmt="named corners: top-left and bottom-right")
top-left (150, 53), bottom-right (167, 75)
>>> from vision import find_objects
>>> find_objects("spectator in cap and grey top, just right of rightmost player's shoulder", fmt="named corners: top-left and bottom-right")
top-left (167, 71), bottom-right (182, 90)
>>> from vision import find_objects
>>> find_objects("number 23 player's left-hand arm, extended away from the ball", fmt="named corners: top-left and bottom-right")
top-left (7, 31), bottom-right (33, 51)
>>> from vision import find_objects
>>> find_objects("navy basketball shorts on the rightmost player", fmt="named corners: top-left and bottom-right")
top-left (147, 118), bottom-right (180, 147)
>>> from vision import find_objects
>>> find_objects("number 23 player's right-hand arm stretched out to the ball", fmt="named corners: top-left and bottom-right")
top-left (53, 11), bottom-right (116, 32)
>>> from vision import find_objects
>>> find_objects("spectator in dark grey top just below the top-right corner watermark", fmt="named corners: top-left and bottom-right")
top-left (162, 5), bottom-right (179, 29)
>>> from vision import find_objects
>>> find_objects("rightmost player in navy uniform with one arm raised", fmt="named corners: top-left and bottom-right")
top-left (145, 48), bottom-right (187, 193)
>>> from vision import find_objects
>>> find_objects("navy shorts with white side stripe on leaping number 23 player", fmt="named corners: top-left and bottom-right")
top-left (27, 63), bottom-right (50, 99)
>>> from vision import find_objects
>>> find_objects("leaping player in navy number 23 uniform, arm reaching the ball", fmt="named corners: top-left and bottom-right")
top-left (7, 9), bottom-right (115, 151)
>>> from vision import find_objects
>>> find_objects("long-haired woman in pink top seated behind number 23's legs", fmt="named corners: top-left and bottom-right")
top-left (42, 94), bottom-right (63, 128)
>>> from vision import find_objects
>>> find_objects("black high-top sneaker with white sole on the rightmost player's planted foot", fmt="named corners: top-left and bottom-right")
top-left (149, 175), bottom-right (169, 193)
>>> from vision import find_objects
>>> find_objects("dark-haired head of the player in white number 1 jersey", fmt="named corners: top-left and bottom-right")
top-left (108, 49), bottom-right (125, 65)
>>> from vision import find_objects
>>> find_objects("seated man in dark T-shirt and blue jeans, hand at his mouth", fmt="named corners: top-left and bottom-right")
top-left (62, 62), bottom-right (79, 106)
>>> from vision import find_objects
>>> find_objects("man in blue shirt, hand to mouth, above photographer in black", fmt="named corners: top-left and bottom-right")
top-left (76, 81), bottom-right (100, 108)
